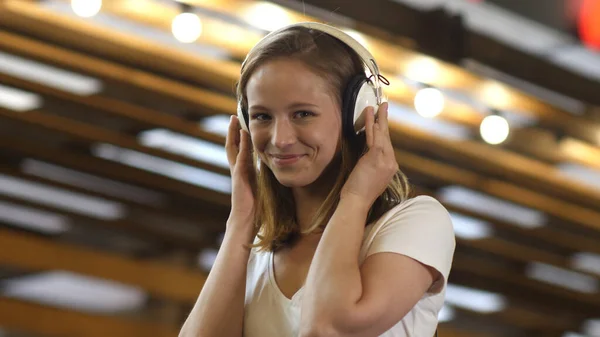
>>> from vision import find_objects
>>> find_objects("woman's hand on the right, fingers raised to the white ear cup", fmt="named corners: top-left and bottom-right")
top-left (340, 102), bottom-right (398, 208)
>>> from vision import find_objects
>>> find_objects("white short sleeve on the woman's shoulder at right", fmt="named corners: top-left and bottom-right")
top-left (365, 196), bottom-right (456, 294)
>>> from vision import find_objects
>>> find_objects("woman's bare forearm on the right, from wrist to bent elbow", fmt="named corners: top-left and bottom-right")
top-left (301, 198), bottom-right (368, 327)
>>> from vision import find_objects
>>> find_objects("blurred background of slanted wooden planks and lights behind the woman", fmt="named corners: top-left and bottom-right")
top-left (0, 0), bottom-right (600, 337)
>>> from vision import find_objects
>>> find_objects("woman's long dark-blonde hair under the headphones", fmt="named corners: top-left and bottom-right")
top-left (237, 27), bottom-right (410, 251)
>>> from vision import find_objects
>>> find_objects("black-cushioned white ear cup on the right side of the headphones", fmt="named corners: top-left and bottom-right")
top-left (342, 74), bottom-right (377, 135)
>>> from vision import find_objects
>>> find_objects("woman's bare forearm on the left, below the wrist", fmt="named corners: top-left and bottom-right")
top-left (179, 215), bottom-right (252, 337)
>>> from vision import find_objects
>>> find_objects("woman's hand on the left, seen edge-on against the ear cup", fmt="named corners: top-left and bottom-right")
top-left (225, 116), bottom-right (256, 220)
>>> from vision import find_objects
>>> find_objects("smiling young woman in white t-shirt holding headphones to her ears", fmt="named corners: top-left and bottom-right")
top-left (180, 23), bottom-right (455, 337)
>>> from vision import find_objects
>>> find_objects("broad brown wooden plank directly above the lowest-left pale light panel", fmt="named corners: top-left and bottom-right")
top-left (0, 229), bottom-right (206, 302)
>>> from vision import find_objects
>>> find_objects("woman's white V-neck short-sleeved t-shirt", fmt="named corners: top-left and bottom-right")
top-left (244, 196), bottom-right (456, 337)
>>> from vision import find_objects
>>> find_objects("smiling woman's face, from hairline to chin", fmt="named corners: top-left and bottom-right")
top-left (246, 59), bottom-right (341, 187)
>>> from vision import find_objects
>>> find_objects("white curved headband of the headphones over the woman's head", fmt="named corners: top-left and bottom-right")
top-left (242, 22), bottom-right (382, 98)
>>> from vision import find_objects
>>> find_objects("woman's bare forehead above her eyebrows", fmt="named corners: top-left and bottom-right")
top-left (246, 59), bottom-right (331, 106)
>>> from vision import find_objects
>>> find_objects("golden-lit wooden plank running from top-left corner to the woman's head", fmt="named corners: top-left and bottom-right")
top-left (0, 0), bottom-right (239, 94)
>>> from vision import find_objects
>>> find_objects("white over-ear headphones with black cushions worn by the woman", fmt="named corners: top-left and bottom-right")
top-left (237, 22), bottom-right (388, 134)
